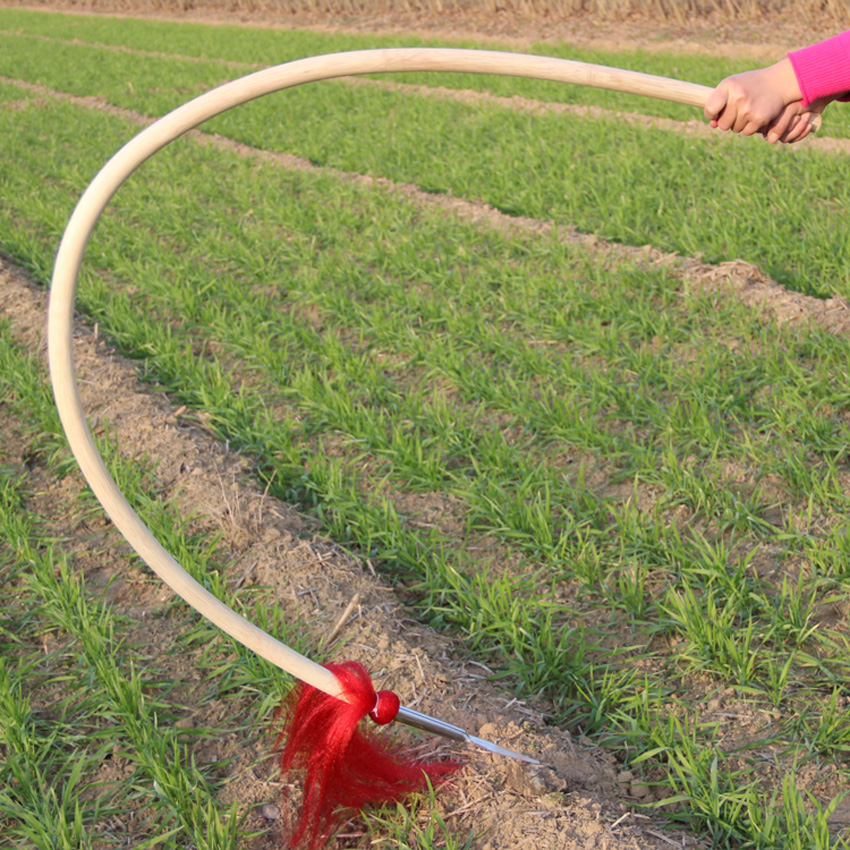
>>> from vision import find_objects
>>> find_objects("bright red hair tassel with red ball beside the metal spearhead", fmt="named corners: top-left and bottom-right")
top-left (275, 661), bottom-right (459, 850)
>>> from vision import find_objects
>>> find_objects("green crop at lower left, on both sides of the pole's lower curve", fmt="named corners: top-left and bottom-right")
top-left (0, 302), bottom-right (454, 850)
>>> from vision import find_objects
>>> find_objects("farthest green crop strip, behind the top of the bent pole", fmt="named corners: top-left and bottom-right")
top-left (0, 9), bottom-right (850, 136)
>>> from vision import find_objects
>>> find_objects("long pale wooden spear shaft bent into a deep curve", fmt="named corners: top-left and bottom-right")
top-left (48, 48), bottom-right (711, 696)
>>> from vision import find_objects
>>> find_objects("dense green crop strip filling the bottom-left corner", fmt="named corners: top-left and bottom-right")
top-left (0, 464), bottom-right (238, 848)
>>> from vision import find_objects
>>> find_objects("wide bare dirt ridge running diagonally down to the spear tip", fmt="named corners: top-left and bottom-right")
top-left (0, 259), bottom-right (701, 850)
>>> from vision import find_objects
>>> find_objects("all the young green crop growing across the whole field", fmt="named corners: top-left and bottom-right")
top-left (0, 9), bottom-right (850, 850)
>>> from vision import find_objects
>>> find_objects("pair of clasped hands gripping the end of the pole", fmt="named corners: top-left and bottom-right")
top-left (705, 59), bottom-right (826, 144)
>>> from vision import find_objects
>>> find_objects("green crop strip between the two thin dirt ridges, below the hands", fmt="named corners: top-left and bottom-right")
top-left (0, 12), bottom-right (850, 302)
